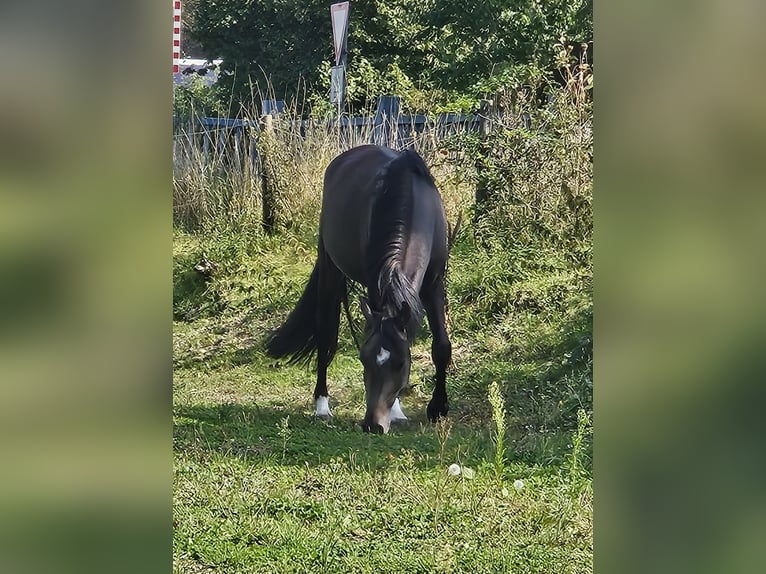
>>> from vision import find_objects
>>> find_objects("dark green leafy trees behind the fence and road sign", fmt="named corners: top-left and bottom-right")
top-left (189, 0), bottom-right (593, 114)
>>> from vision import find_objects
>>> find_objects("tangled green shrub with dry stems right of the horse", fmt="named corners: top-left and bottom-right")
top-left (446, 103), bottom-right (593, 260)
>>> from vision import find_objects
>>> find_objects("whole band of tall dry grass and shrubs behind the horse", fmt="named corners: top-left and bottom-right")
top-left (173, 59), bottom-right (593, 254)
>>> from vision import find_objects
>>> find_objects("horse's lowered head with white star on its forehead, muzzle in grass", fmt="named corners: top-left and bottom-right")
top-left (359, 298), bottom-right (412, 433)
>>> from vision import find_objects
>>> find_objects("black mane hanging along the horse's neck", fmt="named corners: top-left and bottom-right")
top-left (367, 150), bottom-right (434, 338)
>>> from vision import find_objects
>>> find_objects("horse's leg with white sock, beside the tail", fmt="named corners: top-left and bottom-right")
top-left (314, 238), bottom-right (346, 418)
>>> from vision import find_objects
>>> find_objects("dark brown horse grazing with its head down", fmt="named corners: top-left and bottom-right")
top-left (266, 145), bottom-right (452, 432)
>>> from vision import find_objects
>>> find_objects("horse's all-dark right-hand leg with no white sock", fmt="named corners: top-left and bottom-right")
top-left (422, 276), bottom-right (452, 422)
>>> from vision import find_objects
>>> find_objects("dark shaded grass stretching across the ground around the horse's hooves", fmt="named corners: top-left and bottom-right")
top-left (174, 302), bottom-right (592, 468)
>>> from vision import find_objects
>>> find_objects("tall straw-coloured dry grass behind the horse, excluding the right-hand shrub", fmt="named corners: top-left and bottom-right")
top-left (173, 106), bottom-right (480, 238)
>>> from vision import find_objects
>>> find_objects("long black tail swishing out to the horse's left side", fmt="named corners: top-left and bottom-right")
top-left (266, 257), bottom-right (321, 363)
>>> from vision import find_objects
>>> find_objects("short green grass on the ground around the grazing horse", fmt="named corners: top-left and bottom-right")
top-left (173, 227), bottom-right (593, 574)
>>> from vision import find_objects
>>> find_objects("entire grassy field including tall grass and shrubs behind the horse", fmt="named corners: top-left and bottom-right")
top-left (173, 79), bottom-right (593, 574)
